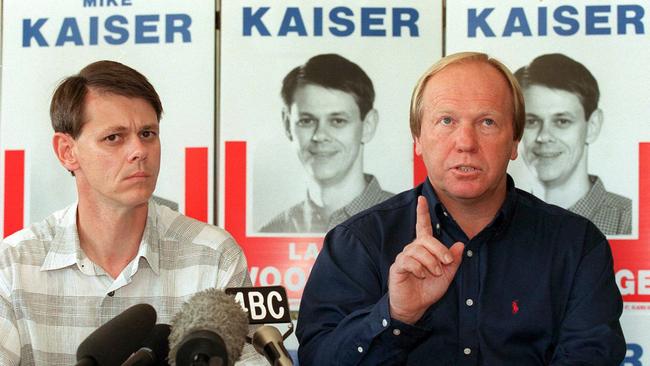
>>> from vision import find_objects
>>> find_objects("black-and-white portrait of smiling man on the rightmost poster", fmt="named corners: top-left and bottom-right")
top-left (515, 53), bottom-right (632, 235)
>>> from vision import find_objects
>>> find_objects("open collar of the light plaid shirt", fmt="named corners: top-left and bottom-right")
top-left (41, 200), bottom-right (160, 275)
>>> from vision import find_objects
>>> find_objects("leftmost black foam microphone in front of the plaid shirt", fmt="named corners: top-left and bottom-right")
top-left (76, 304), bottom-right (156, 366)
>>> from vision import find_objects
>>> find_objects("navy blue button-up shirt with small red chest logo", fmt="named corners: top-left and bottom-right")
top-left (296, 177), bottom-right (625, 366)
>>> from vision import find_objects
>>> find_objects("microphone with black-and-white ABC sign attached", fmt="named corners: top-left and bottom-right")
top-left (226, 286), bottom-right (293, 366)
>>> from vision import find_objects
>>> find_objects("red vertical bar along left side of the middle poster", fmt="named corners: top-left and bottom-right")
top-left (224, 141), bottom-right (246, 245)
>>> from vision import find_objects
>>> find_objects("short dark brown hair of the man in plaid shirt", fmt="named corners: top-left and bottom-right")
top-left (50, 60), bottom-right (163, 139)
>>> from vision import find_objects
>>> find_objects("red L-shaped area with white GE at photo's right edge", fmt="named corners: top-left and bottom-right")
top-left (609, 143), bottom-right (650, 302)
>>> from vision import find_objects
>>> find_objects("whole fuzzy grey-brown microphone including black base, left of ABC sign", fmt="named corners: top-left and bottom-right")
top-left (169, 288), bottom-right (248, 366)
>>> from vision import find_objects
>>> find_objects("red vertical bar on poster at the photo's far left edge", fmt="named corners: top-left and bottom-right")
top-left (3, 150), bottom-right (25, 237)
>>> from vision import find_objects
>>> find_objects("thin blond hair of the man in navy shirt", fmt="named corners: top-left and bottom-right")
top-left (409, 52), bottom-right (526, 141)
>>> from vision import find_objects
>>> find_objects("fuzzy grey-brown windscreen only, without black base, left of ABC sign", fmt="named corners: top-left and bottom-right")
top-left (169, 288), bottom-right (248, 365)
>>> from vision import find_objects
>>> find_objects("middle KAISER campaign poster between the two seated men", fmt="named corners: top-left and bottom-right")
top-left (218, 0), bottom-right (442, 310)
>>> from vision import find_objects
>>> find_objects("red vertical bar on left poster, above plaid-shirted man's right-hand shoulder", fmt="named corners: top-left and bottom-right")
top-left (185, 147), bottom-right (208, 222)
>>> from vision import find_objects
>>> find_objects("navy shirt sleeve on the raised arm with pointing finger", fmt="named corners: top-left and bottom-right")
top-left (296, 226), bottom-right (429, 365)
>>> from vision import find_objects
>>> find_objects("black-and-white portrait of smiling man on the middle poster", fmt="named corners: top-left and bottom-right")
top-left (253, 53), bottom-right (393, 235)
